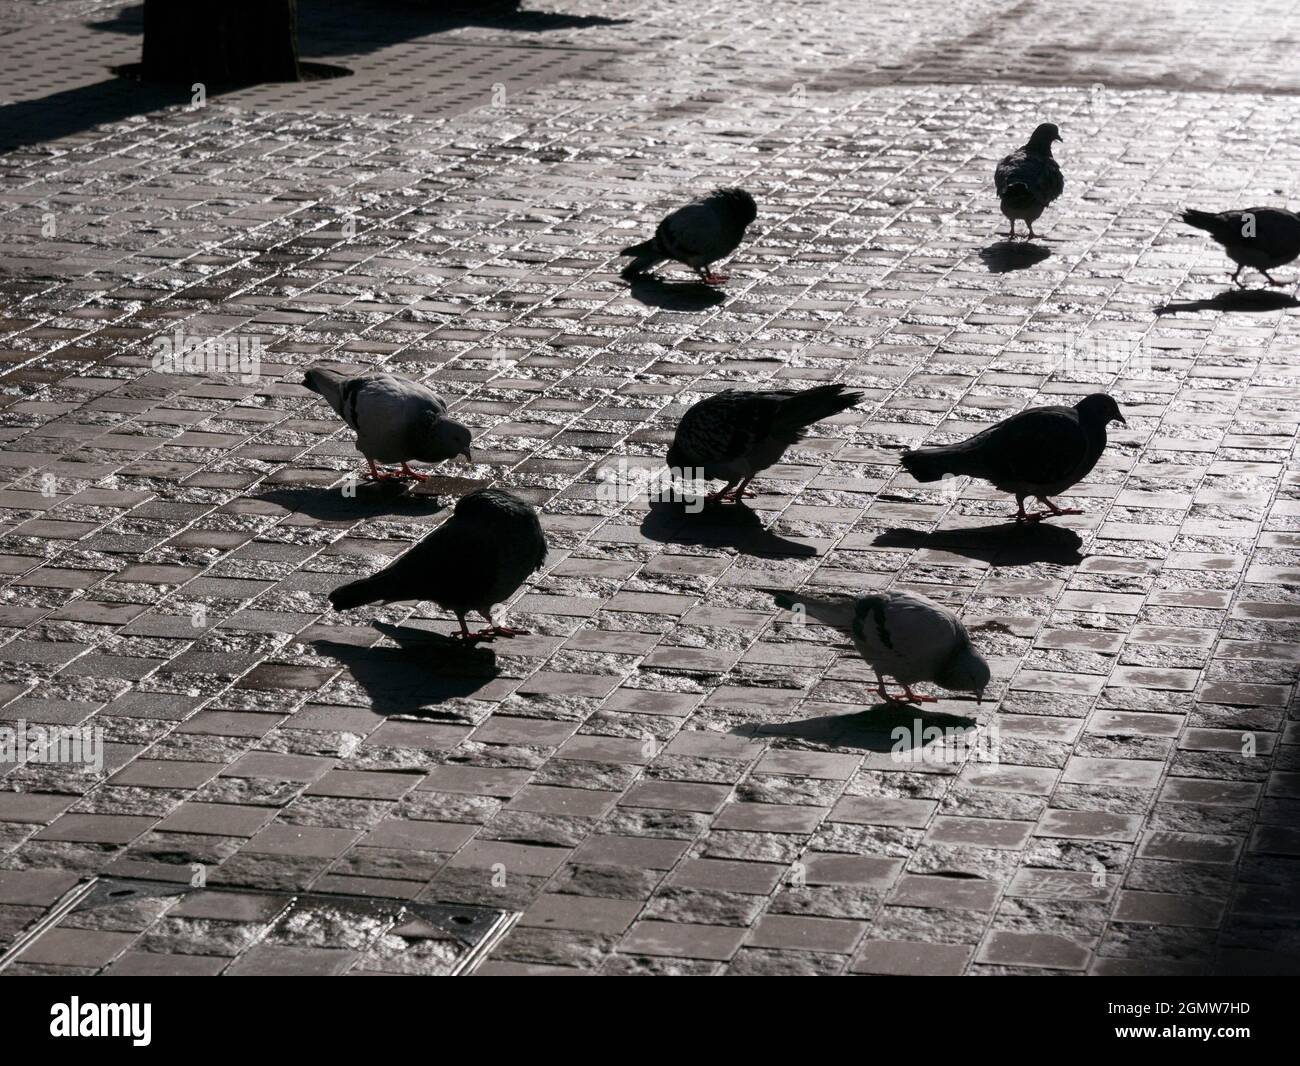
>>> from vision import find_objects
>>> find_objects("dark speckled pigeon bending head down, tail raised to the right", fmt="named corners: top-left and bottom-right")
top-left (667, 385), bottom-right (862, 503)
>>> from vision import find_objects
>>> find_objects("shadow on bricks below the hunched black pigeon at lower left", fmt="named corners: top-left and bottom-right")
top-left (312, 623), bottom-right (498, 722)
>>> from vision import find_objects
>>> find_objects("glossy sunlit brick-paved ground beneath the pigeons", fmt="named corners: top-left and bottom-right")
top-left (0, 0), bottom-right (1300, 974)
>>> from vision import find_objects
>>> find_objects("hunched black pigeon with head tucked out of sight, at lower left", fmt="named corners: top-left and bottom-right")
top-left (329, 489), bottom-right (546, 644)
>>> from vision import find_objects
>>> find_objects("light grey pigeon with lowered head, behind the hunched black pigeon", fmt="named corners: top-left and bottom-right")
top-left (303, 367), bottom-right (472, 481)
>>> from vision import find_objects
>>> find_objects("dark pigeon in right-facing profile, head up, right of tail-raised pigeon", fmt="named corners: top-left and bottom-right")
top-left (902, 393), bottom-right (1127, 523)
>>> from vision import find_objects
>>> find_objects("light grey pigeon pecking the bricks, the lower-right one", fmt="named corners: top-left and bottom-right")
top-left (763, 589), bottom-right (991, 703)
